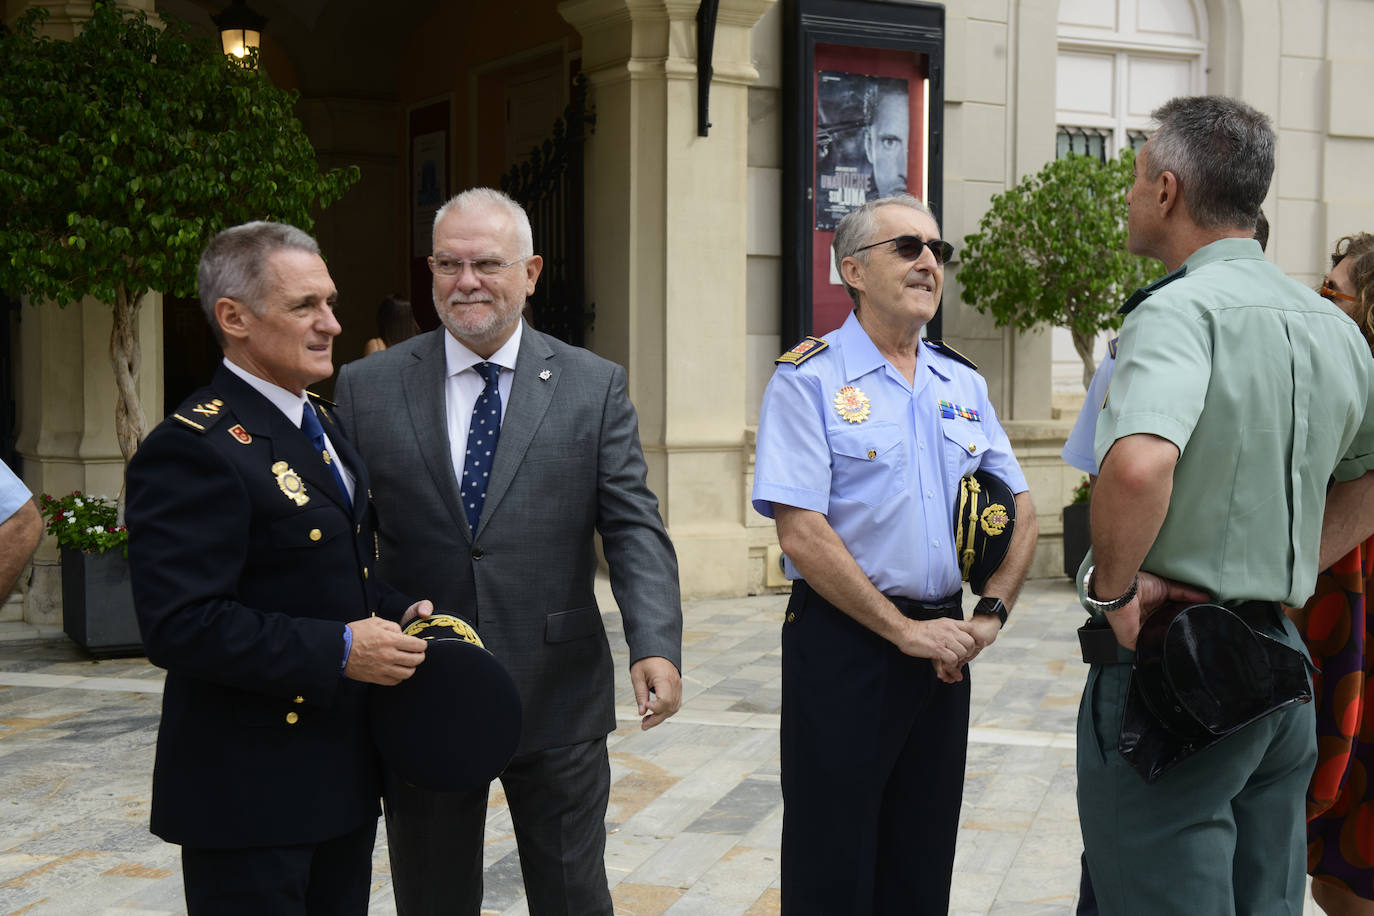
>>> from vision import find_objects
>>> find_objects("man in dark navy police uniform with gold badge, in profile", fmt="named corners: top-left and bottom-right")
top-left (128, 222), bottom-right (431, 916)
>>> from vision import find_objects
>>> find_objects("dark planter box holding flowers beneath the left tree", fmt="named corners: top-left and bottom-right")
top-left (62, 548), bottom-right (143, 658)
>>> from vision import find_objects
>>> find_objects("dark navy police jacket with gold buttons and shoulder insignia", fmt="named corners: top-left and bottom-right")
top-left (128, 365), bottom-right (411, 849)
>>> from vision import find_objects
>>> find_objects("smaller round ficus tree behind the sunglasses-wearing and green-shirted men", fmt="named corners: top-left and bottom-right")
top-left (959, 147), bottom-right (1160, 575)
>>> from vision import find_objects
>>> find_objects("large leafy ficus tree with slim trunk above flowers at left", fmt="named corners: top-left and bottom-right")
top-left (0, 0), bottom-right (359, 650)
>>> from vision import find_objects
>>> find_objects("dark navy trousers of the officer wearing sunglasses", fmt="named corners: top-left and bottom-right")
top-left (782, 580), bottom-right (969, 916)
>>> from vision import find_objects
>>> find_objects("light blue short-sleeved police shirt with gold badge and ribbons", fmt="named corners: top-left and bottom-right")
top-left (753, 314), bottom-right (1028, 602)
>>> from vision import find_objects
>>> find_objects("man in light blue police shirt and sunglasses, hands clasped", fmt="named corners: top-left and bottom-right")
top-left (753, 195), bottom-right (1036, 916)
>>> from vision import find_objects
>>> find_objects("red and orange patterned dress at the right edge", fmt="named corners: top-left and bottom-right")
top-left (1298, 538), bottom-right (1374, 900)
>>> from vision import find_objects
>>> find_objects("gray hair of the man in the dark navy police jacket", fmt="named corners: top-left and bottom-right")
top-left (196, 220), bottom-right (320, 349)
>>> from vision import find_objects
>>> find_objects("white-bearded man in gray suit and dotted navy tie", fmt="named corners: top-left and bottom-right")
top-left (335, 188), bottom-right (682, 916)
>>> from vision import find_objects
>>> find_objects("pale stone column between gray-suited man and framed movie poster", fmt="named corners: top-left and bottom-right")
top-left (559, 0), bottom-right (774, 596)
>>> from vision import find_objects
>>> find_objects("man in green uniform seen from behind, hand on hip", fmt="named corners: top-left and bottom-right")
top-left (1077, 96), bottom-right (1374, 916)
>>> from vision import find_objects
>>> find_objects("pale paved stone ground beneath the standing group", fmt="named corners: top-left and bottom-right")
top-left (0, 581), bottom-right (1319, 916)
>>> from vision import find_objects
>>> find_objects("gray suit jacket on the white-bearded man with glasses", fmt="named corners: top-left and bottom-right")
top-left (335, 325), bottom-right (682, 754)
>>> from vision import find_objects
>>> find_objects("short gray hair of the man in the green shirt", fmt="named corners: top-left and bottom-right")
top-left (1146, 95), bottom-right (1274, 229)
